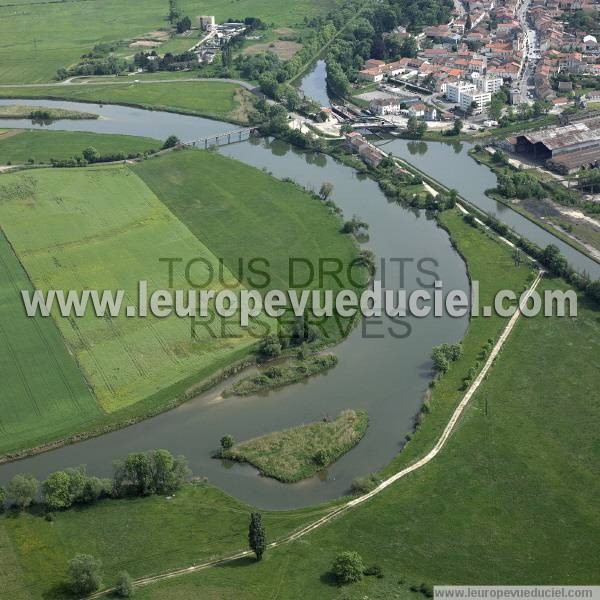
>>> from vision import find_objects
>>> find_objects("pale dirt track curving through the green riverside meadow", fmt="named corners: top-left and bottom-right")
top-left (86, 270), bottom-right (544, 598)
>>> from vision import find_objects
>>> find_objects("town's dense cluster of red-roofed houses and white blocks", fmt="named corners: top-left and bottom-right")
top-left (358, 0), bottom-right (600, 112)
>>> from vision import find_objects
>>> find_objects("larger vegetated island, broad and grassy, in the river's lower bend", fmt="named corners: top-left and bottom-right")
top-left (218, 410), bottom-right (369, 483)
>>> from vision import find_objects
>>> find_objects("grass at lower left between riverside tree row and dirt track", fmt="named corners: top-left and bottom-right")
top-left (0, 484), bottom-right (324, 600)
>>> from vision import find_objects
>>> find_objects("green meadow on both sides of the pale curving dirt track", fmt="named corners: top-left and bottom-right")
top-left (0, 212), bottom-right (600, 600)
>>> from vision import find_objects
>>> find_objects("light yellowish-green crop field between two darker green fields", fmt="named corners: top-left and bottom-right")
top-left (0, 167), bottom-right (254, 412)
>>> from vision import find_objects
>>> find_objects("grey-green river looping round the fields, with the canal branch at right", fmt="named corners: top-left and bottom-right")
top-left (0, 91), bottom-right (600, 509)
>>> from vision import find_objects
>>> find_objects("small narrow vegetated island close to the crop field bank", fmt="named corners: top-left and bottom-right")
top-left (223, 354), bottom-right (338, 397)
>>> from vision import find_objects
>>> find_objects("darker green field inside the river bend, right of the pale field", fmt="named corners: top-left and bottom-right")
top-left (131, 150), bottom-right (360, 339)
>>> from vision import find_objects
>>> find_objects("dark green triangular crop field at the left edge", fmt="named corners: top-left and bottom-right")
top-left (0, 232), bottom-right (100, 454)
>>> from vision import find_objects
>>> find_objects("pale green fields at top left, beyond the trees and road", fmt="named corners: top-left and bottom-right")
top-left (0, 0), bottom-right (333, 83)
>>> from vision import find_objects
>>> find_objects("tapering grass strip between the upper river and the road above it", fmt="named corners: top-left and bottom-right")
top-left (0, 80), bottom-right (250, 122)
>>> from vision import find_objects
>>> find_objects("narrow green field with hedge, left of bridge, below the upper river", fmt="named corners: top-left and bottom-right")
top-left (0, 129), bottom-right (161, 165)
